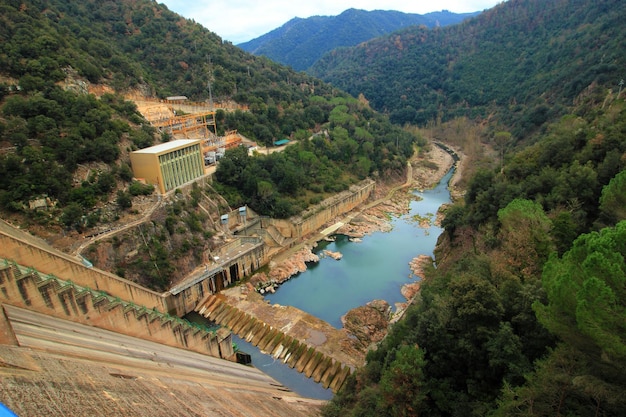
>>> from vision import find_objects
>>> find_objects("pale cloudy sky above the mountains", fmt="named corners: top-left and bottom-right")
top-left (157, 0), bottom-right (502, 45)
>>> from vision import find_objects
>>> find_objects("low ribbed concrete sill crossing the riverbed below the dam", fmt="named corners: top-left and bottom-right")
top-left (196, 294), bottom-right (355, 392)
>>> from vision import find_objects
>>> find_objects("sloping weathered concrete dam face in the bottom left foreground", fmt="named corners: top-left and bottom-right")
top-left (0, 306), bottom-right (323, 417)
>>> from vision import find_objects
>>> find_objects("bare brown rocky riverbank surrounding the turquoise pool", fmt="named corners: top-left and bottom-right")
top-left (226, 142), bottom-right (455, 367)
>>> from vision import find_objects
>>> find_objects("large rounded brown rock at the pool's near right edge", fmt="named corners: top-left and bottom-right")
top-left (341, 300), bottom-right (391, 352)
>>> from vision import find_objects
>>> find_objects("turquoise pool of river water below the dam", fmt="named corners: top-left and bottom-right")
top-left (265, 171), bottom-right (452, 328)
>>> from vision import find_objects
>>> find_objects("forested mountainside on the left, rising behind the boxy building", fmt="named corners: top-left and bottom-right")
top-left (0, 0), bottom-right (415, 229)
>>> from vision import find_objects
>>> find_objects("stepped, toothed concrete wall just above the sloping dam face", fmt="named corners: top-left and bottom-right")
top-left (0, 259), bottom-right (234, 358)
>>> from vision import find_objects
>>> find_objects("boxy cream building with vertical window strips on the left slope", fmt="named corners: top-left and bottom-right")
top-left (130, 139), bottom-right (204, 194)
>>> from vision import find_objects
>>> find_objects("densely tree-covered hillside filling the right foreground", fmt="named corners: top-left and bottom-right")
top-left (324, 83), bottom-right (626, 417)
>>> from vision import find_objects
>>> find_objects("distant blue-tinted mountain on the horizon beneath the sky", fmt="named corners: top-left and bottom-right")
top-left (238, 9), bottom-right (478, 71)
